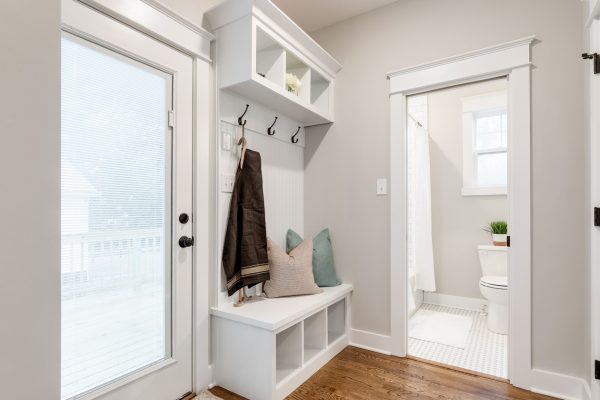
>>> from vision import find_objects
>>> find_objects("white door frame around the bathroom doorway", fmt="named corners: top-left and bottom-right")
top-left (388, 36), bottom-right (535, 389)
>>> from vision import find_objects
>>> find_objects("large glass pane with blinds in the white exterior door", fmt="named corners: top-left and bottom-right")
top-left (61, 35), bottom-right (171, 398)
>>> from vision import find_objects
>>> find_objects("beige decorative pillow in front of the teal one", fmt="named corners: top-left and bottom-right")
top-left (264, 238), bottom-right (321, 297)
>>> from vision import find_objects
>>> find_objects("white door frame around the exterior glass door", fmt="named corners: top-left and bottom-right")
top-left (61, 0), bottom-right (215, 392)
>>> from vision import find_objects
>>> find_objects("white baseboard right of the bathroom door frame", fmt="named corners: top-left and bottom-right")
top-left (531, 369), bottom-right (592, 400)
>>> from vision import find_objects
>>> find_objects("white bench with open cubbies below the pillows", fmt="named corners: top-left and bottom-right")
top-left (211, 284), bottom-right (353, 400)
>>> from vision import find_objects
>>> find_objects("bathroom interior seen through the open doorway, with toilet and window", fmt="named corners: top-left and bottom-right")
top-left (406, 77), bottom-right (510, 379)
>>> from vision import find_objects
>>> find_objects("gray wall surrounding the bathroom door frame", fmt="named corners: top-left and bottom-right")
top-left (305, 0), bottom-right (589, 377)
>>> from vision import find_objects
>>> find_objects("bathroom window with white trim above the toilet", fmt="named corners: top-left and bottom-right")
top-left (462, 91), bottom-right (508, 196)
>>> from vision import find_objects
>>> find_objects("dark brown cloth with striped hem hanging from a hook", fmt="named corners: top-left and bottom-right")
top-left (223, 150), bottom-right (269, 296)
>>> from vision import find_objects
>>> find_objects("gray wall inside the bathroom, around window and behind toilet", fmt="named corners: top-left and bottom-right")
top-left (427, 79), bottom-right (508, 298)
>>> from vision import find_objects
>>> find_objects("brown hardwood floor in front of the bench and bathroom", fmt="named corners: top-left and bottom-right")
top-left (211, 347), bottom-right (552, 400)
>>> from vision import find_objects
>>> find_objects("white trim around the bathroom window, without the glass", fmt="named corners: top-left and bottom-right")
top-left (461, 90), bottom-right (508, 196)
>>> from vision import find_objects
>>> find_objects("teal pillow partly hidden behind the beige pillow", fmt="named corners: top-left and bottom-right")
top-left (286, 229), bottom-right (342, 287)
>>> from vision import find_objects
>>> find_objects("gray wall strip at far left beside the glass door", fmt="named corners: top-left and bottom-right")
top-left (0, 0), bottom-right (60, 400)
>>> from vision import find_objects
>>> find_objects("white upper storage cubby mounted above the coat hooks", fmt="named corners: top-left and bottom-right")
top-left (206, 0), bottom-right (341, 126)
